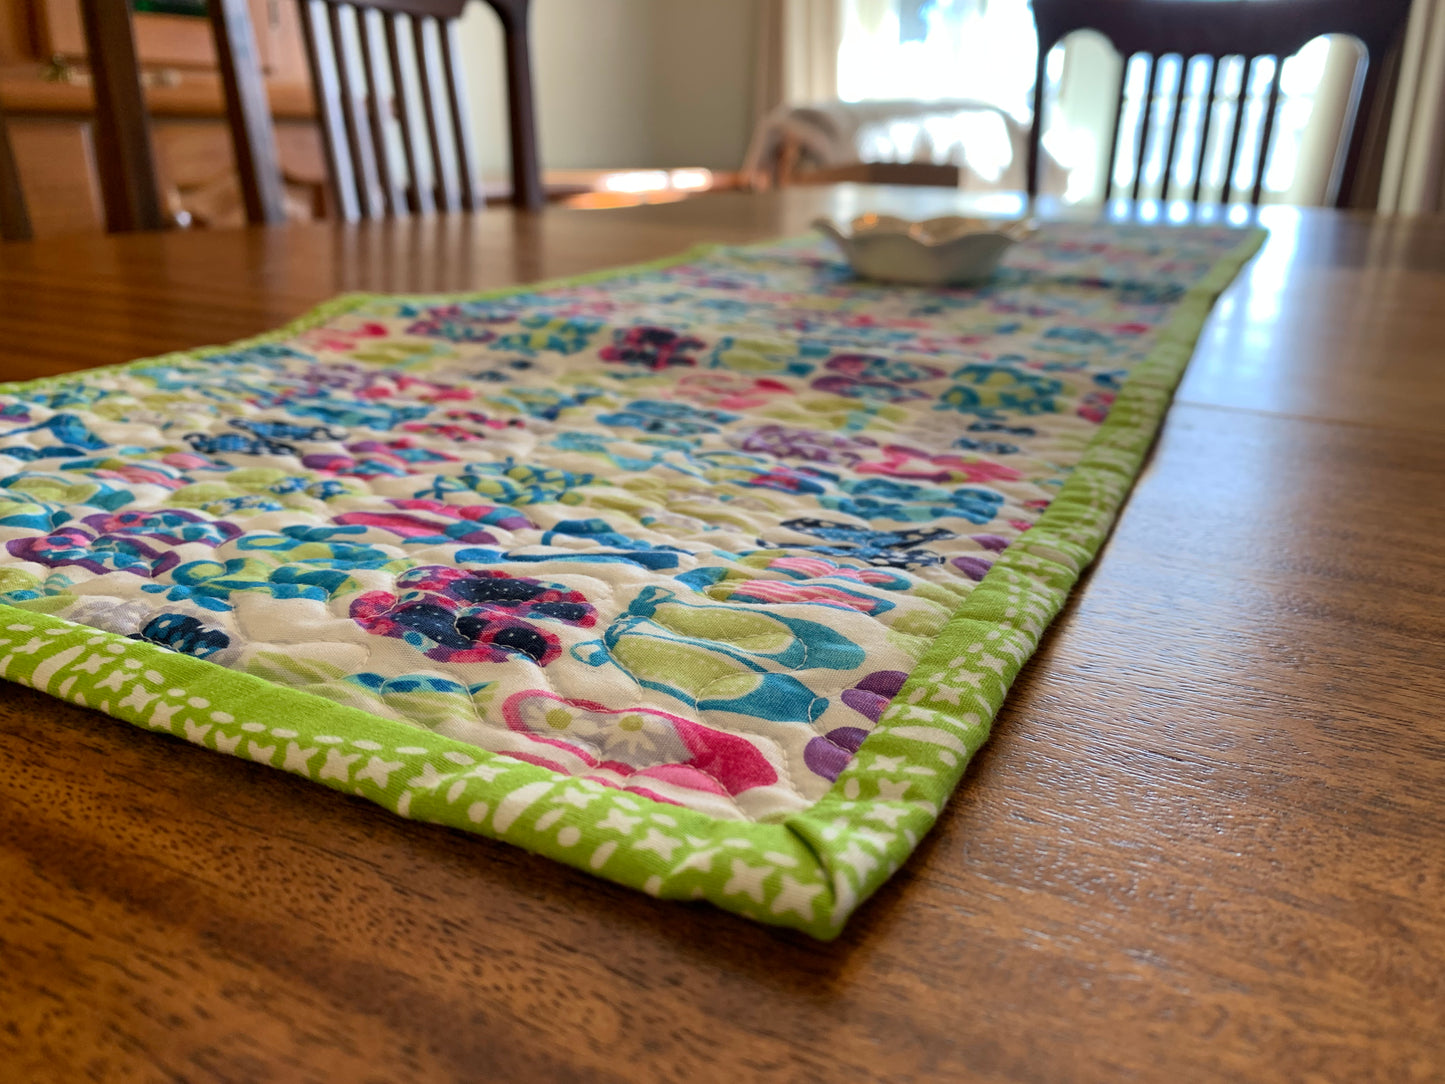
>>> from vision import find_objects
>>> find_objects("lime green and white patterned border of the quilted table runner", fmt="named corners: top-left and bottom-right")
top-left (0, 230), bottom-right (1264, 939)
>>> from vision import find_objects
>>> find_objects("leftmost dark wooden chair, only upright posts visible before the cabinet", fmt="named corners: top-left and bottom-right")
top-left (0, 0), bottom-right (166, 241)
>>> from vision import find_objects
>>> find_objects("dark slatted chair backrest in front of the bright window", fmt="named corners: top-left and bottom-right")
top-left (1029, 0), bottom-right (1410, 205)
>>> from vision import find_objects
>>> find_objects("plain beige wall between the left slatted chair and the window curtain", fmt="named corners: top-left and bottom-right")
top-left (462, 0), bottom-right (759, 175)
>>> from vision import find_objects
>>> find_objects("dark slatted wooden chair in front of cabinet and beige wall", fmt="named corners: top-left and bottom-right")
top-left (210, 0), bottom-right (542, 223)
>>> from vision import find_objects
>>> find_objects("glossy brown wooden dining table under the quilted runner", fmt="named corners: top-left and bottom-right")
top-left (0, 186), bottom-right (1445, 1081)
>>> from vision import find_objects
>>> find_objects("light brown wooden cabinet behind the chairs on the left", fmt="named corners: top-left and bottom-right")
top-left (0, 0), bottom-right (325, 237)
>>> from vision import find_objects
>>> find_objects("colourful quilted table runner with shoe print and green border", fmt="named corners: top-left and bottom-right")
top-left (0, 225), bottom-right (1260, 938)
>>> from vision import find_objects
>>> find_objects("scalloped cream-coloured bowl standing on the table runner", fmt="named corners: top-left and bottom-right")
top-left (814, 214), bottom-right (1033, 286)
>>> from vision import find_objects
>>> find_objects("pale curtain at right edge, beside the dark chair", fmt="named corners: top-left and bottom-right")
top-left (1380, 0), bottom-right (1445, 214)
